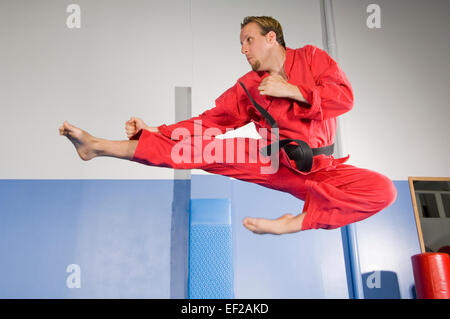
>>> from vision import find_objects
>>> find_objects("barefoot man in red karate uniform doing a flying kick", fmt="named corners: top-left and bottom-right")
top-left (60, 17), bottom-right (397, 234)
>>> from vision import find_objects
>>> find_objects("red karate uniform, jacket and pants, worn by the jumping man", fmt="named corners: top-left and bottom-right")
top-left (132, 45), bottom-right (397, 230)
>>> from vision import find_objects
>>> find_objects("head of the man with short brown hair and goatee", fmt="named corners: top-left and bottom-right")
top-left (240, 16), bottom-right (286, 71)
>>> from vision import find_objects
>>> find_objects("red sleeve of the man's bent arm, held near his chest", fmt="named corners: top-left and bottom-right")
top-left (294, 45), bottom-right (353, 120)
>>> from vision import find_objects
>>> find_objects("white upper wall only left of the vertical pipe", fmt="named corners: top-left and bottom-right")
top-left (0, 0), bottom-right (321, 179)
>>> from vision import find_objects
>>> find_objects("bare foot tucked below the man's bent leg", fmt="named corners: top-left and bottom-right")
top-left (242, 213), bottom-right (305, 235)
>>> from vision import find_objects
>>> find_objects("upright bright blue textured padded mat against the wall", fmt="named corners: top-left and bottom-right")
top-left (188, 199), bottom-right (234, 299)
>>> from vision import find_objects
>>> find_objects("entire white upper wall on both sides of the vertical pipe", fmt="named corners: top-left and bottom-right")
top-left (0, 0), bottom-right (450, 180)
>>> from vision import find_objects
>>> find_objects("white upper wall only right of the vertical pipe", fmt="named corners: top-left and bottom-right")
top-left (333, 0), bottom-right (450, 180)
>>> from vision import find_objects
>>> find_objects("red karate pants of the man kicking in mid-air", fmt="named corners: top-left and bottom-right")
top-left (131, 130), bottom-right (397, 230)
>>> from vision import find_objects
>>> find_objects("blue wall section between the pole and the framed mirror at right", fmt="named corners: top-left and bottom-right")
top-left (356, 181), bottom-right (420, 298)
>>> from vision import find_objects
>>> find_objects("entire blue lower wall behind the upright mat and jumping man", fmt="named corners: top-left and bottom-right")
top-left (0, 179), bottom-right (420, 298)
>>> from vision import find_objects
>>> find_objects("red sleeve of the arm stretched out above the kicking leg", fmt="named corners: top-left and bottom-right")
top-left (158, 84), bottom-right (250, 137)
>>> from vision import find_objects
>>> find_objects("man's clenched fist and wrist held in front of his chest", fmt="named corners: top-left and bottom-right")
top-left (258, 74), bottom-right (307, 102)
